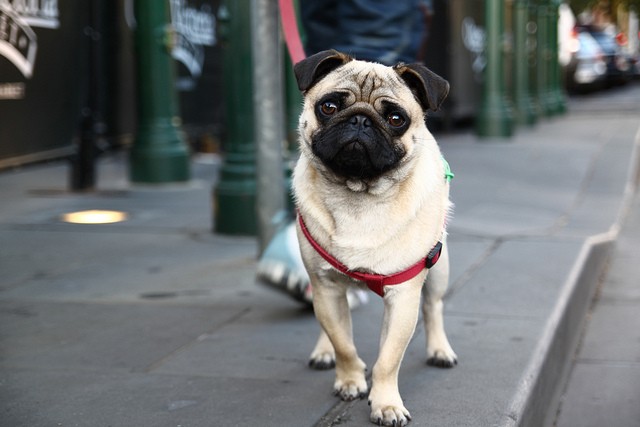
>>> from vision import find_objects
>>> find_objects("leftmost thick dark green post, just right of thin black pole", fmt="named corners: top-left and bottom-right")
top-left (130, 0), bottom-right (190, 183)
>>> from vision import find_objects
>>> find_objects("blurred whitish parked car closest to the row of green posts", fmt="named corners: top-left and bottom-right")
top-left (565, 31), bottom-right (607, 91)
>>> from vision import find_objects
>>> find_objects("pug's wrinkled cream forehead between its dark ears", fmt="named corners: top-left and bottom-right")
top-left (308, 61), bottom-right (410, 104)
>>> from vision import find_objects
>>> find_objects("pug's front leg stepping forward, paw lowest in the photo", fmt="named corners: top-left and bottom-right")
top-left (369, 280), bottom-right (424, 426)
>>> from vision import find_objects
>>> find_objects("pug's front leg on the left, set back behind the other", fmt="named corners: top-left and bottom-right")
top-left (310, 276), bottom-right (368, 400)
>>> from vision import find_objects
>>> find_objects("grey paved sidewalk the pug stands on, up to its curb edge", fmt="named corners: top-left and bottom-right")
top-left (0, 83), bottom-right (640, 427)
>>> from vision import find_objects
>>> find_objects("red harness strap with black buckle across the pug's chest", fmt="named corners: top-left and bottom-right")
top-left (298, 212), bottom-right (442, 297)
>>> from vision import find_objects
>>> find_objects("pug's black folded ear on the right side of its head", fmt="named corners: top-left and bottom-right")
top-left (394, 64), bottom-right (449, 111)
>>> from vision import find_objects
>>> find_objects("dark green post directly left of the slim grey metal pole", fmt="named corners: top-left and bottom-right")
top-left (213, 0), bottom-right (258, 236)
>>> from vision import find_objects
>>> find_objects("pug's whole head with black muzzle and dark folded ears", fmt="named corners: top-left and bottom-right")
top-left (294, 51), bottom-right (449, 189)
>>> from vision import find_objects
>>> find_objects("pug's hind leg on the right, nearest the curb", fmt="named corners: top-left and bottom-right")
top-left (422, 243), bottom-right (458, 368)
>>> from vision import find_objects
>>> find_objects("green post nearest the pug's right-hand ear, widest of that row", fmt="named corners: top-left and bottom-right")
top-left (476, 0), bottom-right (513, 137)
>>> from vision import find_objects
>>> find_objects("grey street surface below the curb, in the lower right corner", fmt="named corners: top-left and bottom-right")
top-left (556, 175), bottom-right (640, 427)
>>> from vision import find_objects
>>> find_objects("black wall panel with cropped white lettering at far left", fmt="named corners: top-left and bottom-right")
top-left (0, 0), bottom-right (87, 168)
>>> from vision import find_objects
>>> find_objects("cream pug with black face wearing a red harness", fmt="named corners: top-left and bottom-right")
top-left (293, 50), bottom-right (457, 426)
